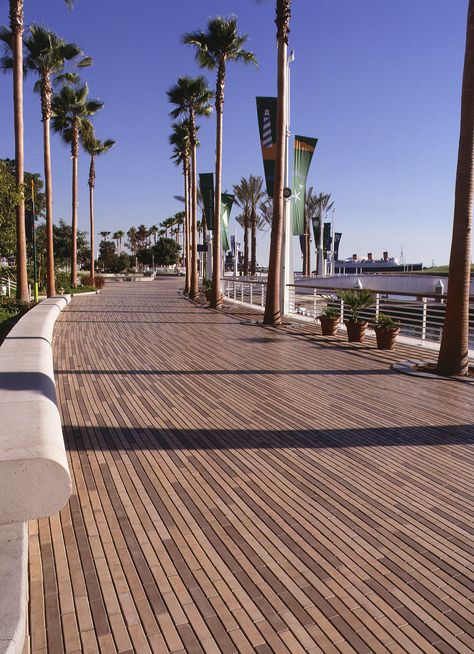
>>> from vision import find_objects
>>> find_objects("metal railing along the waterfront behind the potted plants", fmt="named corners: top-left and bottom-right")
top-left (223, 279), bottom-right (474, 351)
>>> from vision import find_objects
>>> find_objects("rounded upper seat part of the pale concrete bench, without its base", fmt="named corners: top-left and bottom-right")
top-left (0, 297), bottom-right (71, 524)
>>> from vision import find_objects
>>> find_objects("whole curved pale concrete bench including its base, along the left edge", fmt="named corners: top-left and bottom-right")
top-left (0, 296), bottom-right (71, 654)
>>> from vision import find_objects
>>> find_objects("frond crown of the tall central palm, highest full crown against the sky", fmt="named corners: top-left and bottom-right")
top-left (182, 16), bottom-right (257, 70)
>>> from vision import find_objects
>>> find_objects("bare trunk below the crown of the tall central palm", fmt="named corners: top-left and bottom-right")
top-left (211, 61), bottom-right (225, 309)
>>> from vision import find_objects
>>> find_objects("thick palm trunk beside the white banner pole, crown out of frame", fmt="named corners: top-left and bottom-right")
top-left (263, 0), bottom-right (291, 325)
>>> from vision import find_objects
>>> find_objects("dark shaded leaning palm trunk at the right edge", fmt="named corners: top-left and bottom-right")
top-left (438, 0), bottom-right (474, 375)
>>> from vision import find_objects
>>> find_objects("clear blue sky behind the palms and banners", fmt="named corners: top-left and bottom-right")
top-left (0, 0), bottom-right (467, 268)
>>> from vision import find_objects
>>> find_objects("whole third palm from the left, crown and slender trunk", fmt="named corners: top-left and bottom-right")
top-left (51, 84), bottom-right (104, 287)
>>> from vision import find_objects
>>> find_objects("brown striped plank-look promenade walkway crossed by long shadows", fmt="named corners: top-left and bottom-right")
top-left (25, 279), bottom-right (474, 654)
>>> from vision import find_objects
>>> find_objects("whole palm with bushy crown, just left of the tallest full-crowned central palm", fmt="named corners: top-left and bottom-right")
top-left (168, 76), bottom-right (213, 299)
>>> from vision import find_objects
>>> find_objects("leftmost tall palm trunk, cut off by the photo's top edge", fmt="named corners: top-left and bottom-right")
top-left (10, 0), bottom-right (29, 302)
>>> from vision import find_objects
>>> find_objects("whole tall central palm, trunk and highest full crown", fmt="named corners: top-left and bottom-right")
top-left (183, 16), bottom-right (257, 309)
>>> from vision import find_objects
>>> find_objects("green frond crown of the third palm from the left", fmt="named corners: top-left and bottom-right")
top-left (52, 84), bottom-right (104, 143)
